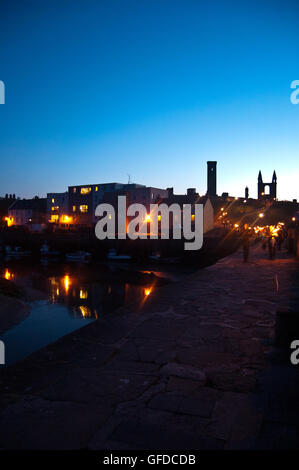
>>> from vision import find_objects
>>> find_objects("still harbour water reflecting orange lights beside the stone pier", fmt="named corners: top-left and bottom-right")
top-left (0, 260), bottom-right (161, 364)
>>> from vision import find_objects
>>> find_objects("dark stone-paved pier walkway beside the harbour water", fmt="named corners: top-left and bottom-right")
top-left (0, 247), bottom-right (299, 450)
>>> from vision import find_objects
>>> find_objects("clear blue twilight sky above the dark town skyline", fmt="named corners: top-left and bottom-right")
top-left (0, 0), bottom-right (299, 199)
